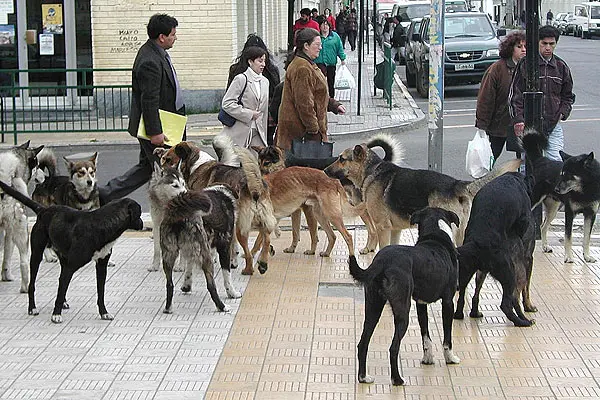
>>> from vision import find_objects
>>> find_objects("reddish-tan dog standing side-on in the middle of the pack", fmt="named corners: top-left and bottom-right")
top-left (252, 146), bottom-right (377, 257)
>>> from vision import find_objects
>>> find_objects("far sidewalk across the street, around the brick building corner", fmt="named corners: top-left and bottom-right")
top-left (0, 40), bottom-right (426, 148)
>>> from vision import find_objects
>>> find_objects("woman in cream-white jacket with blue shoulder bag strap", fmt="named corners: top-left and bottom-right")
top-left (221, 47), bottom-right (269, 148)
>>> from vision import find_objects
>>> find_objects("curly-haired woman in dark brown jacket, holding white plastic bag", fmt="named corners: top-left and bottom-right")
top-left (475, 31), bottom-right (525, 160)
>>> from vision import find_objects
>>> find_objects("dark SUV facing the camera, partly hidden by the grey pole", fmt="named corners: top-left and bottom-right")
top-left (413, 12), bottom-right (506, 97)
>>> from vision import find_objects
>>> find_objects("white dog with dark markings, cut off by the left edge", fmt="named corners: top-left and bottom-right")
top-left (0, 141), bottom-right (44, 293)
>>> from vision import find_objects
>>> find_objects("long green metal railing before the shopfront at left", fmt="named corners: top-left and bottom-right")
top-left (0, 68), bottom-right (131, 144)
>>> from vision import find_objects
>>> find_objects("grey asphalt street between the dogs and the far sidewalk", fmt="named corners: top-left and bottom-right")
top-left (47, 36), bottom-right (600, 211)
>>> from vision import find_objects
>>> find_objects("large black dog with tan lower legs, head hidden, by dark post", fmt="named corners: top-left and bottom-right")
top-left (454, 172), bottom-right (537, 326)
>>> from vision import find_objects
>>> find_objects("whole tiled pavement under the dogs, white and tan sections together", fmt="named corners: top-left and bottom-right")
top-left (0, 219), bottom-right (600, 400)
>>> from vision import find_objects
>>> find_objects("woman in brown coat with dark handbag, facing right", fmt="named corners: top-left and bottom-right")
top-left (275, 28), bottom-right (346, 150)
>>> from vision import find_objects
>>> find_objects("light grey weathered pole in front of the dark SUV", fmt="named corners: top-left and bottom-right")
top-left (427, 0), bottom-right (444, 172)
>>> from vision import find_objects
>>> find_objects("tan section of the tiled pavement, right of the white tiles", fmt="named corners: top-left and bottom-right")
top-left (206, 225), bottom-right (600, 400)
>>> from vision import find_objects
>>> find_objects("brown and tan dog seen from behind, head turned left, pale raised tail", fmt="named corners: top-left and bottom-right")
top-left (157, 135), bottom-right (277, 275)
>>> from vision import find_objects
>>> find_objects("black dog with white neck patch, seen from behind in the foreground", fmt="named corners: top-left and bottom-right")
top-left (350, 208), bottom-right (460, 385)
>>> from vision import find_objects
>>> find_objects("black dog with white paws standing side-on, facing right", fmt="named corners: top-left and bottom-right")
top-left (0, 181), bottom-right (144, 323)
